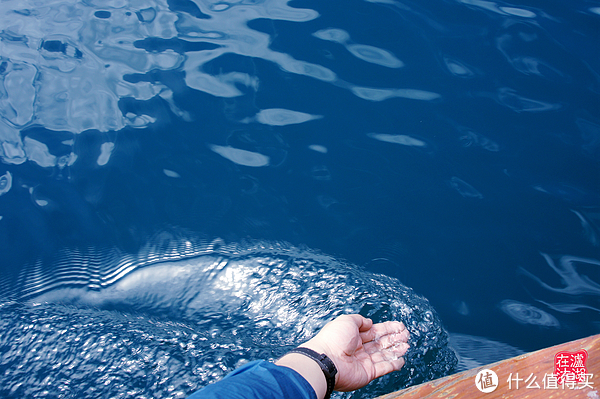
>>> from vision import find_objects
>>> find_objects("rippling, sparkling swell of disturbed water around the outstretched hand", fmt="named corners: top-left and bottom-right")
top-left (0, 239), bottom-right (456, 398)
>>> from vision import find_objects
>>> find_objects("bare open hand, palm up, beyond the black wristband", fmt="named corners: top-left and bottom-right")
top-left (301, 314), bottom-right (409, 391)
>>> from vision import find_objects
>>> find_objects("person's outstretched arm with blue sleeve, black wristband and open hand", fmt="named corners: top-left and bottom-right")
top-left (190, 315), bottom-right (409, 399)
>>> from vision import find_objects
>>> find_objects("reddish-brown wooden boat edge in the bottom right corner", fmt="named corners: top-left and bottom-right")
top-left (377, 334), bottom-right (600, 399)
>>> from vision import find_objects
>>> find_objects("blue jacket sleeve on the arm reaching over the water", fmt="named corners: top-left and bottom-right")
top-left (188, 360), bottom-right (317, 399)
